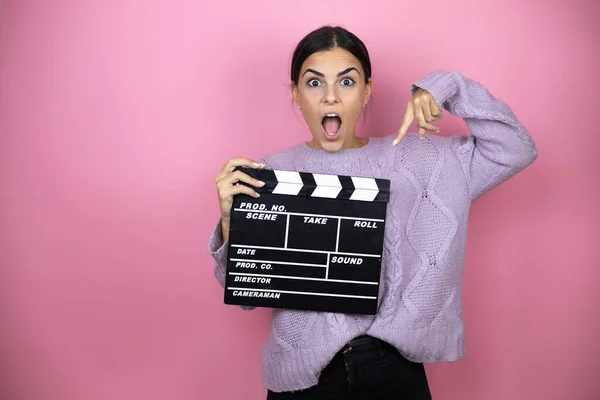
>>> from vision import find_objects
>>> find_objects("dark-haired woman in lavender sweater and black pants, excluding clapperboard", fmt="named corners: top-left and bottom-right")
top-left (209, 27), bottom-right (537, 400)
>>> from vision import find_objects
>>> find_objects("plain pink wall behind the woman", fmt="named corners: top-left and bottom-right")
top-left (0, 0), bottom-right (600, 400)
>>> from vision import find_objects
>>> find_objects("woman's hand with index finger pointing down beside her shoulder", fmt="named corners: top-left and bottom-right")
top-left (393, 88), bottom-right (442, 145)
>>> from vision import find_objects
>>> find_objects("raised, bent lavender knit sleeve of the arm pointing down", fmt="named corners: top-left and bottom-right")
top-left (411, 71), bottom-right (537, 200)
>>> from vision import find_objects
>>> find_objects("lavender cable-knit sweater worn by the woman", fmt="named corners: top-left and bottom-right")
top-left (209, 71), bottom-right (537, 392)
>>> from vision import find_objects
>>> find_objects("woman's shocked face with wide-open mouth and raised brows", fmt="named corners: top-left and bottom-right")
top-left (292, 48), bottom-right (371, 152)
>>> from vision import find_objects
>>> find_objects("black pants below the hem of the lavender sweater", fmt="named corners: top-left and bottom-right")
top-left (267, 336), bottom-right (431, 400)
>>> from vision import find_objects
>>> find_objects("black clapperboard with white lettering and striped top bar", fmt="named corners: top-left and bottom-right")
top-left (225, 167), bottom-right (390, 314)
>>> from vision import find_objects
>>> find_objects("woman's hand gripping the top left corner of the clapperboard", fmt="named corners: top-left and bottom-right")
top-left (215, 157), bottom-right (268, 239)
